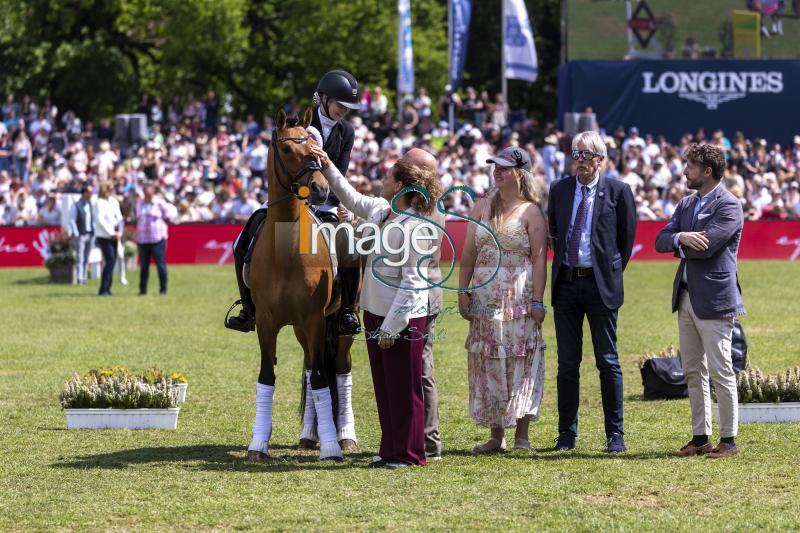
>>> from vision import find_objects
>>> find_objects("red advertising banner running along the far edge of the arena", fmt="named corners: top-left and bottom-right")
top-left (0, 220), bottom-right (800, 267)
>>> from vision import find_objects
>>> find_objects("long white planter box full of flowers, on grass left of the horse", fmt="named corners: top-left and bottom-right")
top-left (59, 367), bottom-right (185, 429)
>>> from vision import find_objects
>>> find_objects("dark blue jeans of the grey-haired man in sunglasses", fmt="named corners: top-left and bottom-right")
top-left (553, 270), bottom-right (623, 437)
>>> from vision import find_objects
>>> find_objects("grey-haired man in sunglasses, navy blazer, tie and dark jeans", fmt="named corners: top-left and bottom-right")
top-left (547, 131), bottom-right (636, 453)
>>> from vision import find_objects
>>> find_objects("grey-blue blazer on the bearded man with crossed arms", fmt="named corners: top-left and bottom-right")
top-left (656, 186), bottom-right (745, 319)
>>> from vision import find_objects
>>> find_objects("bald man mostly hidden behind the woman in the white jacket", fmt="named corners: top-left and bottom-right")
top-left (339, 148), bottom-right (445, 461)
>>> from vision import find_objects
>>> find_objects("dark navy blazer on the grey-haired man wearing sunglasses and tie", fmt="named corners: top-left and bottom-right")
top-left (547, 176), bottom-right (636, 309)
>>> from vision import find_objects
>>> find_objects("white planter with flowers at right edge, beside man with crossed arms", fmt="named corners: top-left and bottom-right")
top-left (714, 367), bottom-right (800, 423)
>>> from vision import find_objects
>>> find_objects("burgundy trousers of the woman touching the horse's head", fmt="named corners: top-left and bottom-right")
top-left (364, 311), bottom-right (427, 465)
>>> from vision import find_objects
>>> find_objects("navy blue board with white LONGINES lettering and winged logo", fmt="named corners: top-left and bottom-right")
top-left (558, 60), bottom-right (800, 146)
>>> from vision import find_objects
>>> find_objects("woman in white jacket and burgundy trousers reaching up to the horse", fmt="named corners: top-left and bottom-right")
top-left (312, 146), bottom-right (441, 468)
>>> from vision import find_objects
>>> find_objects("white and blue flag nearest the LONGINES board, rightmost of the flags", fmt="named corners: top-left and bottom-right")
top-left (503, 0), bottom-right (539, 81)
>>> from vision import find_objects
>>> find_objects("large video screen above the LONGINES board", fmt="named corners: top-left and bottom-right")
top-left (566, 0), bottom-right (800, 61)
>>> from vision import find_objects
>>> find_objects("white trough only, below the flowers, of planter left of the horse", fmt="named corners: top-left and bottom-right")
top-left (64, 407), bottom-right (180, 429)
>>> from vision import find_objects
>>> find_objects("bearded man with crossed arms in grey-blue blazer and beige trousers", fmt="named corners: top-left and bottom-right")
top-left (656, 144), bottom-right (745, 459)
